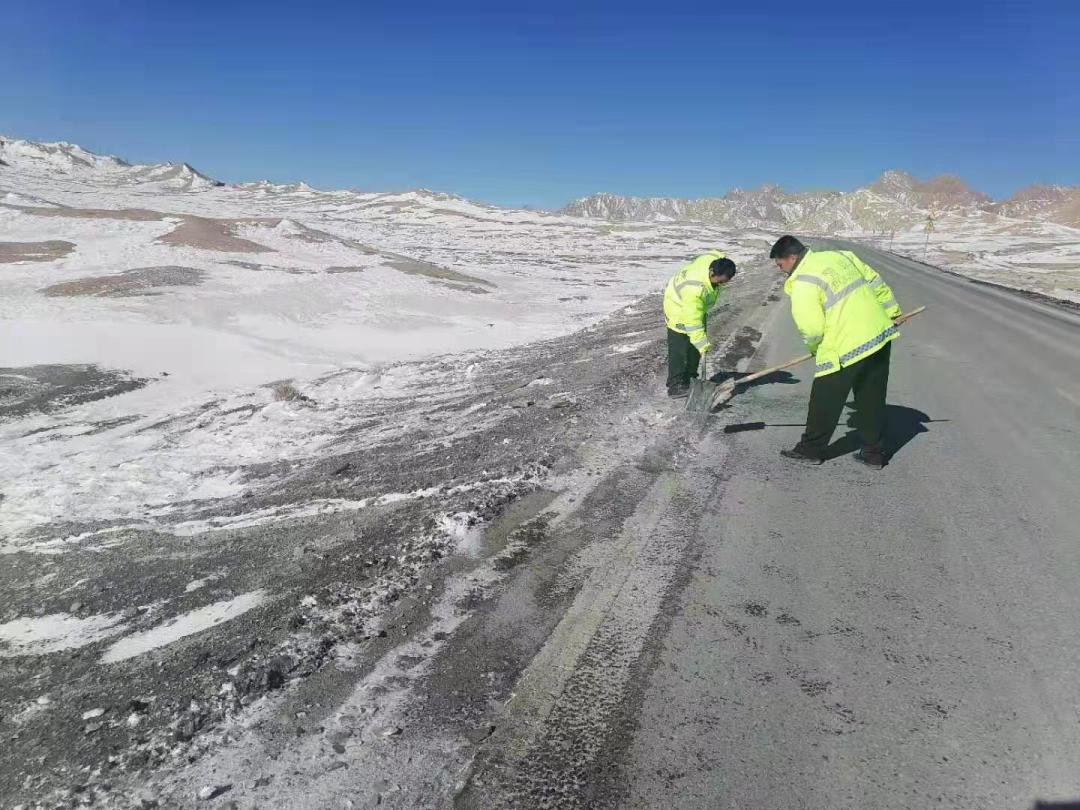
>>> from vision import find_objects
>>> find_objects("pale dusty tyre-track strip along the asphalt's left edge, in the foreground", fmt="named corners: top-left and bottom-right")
top-left (458, 444), bottom-right (723, 809)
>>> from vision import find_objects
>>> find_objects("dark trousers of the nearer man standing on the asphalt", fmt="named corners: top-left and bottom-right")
top-left (797, 343), bottom-right (892, 458)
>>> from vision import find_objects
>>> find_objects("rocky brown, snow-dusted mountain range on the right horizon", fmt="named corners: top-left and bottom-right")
top-left (562, 172), bottom-right (1080, 233)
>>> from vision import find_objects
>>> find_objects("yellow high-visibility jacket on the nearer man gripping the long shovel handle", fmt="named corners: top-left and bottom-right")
top-left (784, 251), bottom-right (900, 377)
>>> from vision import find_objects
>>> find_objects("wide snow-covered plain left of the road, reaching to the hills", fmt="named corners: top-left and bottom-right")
top-left (0, 147), bottom-right (767, 553)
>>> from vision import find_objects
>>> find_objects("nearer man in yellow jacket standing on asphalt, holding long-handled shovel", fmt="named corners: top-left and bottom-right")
top-left (769, 237), bottom-right (900, 470)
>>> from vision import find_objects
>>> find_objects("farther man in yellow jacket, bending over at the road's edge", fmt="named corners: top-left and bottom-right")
top-left (664, 251), bottom-right (735, 397)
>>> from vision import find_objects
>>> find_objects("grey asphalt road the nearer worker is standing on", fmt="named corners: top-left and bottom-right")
top-left (605, 240), bottom-right (1080, 810)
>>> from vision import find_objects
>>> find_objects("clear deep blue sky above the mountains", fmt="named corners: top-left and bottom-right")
top-left (0, 0), bottom-right (1080, 207)
